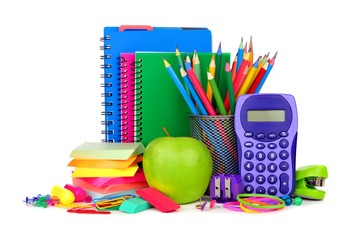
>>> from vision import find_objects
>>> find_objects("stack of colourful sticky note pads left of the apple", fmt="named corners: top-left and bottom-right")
top-left (68, 142), bottom-right (148, 197)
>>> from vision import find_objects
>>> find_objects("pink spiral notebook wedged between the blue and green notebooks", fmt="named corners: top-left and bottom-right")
top-left (120, 53), bottom-right (135, 142)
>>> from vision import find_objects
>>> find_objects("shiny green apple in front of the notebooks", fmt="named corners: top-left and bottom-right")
top-left (143, 136), bottom-right (213, 204)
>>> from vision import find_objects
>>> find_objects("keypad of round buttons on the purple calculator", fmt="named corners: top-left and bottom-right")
top-left (240, 131), bottom-right (291, 195)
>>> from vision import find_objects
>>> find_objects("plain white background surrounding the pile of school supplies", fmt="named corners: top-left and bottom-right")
top-left (0, 0), bottom-right (360, 239)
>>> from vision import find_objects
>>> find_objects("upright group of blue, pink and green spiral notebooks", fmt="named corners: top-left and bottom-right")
top-left (101, 25), bottom-right (212, 144)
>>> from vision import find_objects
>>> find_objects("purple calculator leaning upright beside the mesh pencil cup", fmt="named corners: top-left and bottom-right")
top-left (234, 93), bottom-right (298, 197)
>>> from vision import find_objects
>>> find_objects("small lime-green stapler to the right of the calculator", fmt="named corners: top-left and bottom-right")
top-left (294, 165), bottom-right (328, 200)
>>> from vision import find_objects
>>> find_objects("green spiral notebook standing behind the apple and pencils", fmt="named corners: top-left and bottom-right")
top-left (135, 52), bottom-right (230, 147)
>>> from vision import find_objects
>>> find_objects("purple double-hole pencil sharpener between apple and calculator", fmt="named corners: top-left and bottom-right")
top-left (210, 174), bottom-right (242, 202)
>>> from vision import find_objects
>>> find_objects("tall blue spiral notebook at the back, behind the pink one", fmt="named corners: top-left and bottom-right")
top-left (100, 25), bottom-right (212, 142)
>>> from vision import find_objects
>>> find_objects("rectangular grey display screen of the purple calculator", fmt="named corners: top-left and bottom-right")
top-left (247, 110), bottom-right (285, 122)
